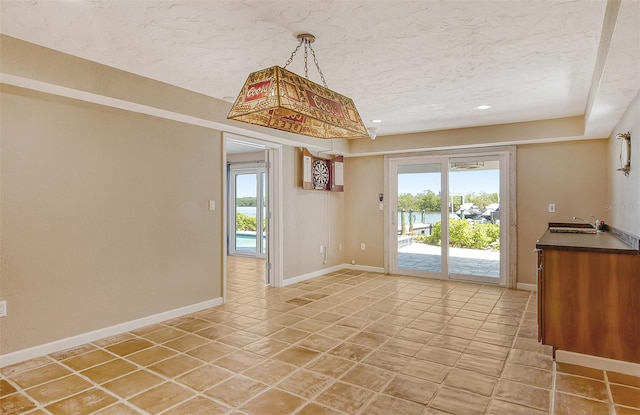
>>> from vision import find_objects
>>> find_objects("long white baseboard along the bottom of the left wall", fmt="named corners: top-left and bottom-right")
top-left (0, 297), bottom-right (223, 367)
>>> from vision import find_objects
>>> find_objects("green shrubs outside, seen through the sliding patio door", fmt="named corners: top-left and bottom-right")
top-left (424, 219), bottom-right (500, 251)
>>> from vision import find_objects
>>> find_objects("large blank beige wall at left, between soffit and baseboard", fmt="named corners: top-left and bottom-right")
top-left (0, 87), bottom-right (223, 354)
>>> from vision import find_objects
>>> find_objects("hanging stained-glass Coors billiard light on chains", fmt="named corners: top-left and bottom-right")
top-left (227, 33), bottom-right (369, 138)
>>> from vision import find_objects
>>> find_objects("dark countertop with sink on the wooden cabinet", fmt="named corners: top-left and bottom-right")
top-left (536, 224), bottom-right (640, 255)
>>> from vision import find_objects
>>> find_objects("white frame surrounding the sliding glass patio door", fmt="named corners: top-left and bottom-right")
top-left (384, 146), bottom-right (517, 288)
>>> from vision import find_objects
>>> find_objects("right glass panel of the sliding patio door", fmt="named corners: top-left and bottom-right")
top-left (448, 157), bottom-right (501, 283)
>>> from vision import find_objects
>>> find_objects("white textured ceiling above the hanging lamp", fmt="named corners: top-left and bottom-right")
top-left (1, 0), bottom-right (640, 139)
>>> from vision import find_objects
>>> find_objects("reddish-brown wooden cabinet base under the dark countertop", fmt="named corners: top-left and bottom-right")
top-left (538, 249), bottom-right (640, 363)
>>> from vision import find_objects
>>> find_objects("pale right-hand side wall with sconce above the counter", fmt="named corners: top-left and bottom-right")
top-left (607, 93), bottom-right (640, 236)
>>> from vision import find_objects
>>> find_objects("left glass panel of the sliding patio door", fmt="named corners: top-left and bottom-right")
top-left (394, 162), bottom-right (446, 276)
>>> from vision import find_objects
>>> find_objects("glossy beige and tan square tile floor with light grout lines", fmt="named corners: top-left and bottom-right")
top-left (0, 257), bottom-right (640, 415)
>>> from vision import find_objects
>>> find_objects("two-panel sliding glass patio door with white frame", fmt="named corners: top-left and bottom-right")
top-left (386, 153), bottom-right (510, 285)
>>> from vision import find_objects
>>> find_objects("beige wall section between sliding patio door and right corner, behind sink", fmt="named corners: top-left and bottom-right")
top-left (516, 140), bottom-right (609, 284)
